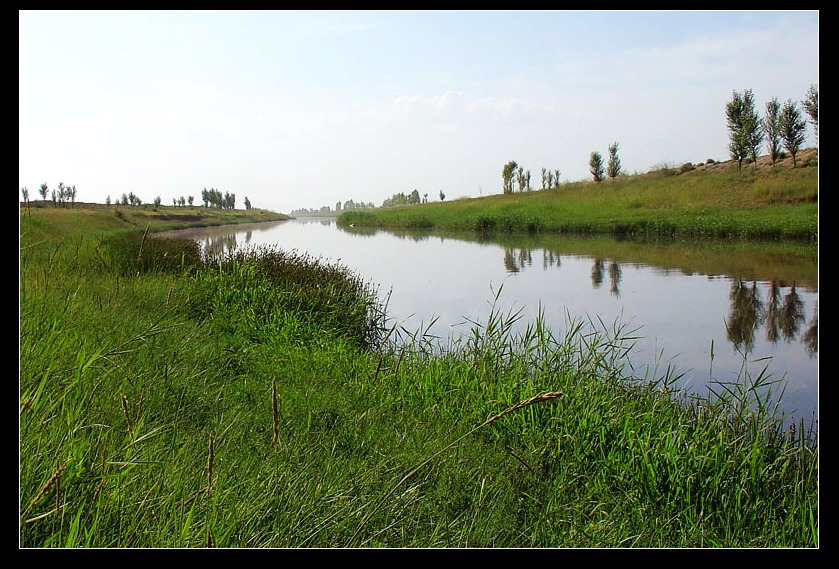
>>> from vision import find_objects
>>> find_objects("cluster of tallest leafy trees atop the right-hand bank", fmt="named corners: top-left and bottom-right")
top-left (725, 84), bottom-right (819, 169)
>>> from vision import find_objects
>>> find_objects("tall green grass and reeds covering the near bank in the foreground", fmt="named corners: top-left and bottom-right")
top-left (19, 202), bottom-right (819, 548)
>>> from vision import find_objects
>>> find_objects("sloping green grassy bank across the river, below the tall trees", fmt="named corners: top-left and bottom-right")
top-left (338, 150), bottom-right (818, 244)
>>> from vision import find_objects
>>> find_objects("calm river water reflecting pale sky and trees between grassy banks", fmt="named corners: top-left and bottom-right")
top-left (161, 215), bottom-right (818, 428)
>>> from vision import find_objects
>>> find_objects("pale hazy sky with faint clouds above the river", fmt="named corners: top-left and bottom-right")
top-left (18, 10), bottom-right (819, 213)
